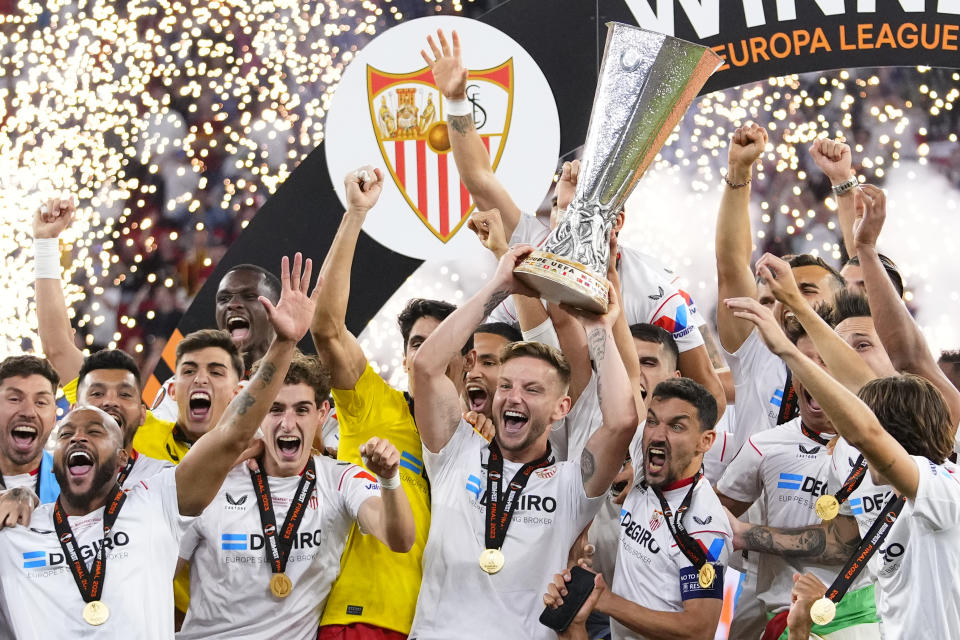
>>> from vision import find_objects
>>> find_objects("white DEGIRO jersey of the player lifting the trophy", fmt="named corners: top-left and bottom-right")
top-left (410, 421), bottom-right (603, 640)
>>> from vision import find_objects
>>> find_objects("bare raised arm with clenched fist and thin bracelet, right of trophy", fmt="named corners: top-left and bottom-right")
top-left (716, 124), bottom-right (767, 353)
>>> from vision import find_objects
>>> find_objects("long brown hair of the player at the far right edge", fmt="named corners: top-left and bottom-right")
top-left (857, 374), bottom-right (953, 464)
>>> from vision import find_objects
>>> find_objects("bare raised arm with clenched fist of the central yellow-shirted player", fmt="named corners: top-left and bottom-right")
top-left (310, 166), bottom-right (383, 389)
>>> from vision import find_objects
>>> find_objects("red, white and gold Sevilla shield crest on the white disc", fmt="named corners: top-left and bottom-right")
top-left (367, 58), bottom-right (513, 243)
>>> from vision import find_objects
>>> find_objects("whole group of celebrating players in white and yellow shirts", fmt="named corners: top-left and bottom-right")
top-left (0, 22), bottom-right (960, 640)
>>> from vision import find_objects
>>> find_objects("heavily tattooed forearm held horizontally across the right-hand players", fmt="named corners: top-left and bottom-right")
top-left (744, 520), bottom-right (860, 564)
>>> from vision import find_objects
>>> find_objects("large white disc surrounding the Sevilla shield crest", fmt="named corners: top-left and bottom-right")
top-left (325, 16), bottom-right (560, 260)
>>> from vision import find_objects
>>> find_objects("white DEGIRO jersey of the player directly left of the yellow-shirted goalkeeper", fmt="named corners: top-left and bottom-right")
top-left (177, 456), bottom-right (376, 640)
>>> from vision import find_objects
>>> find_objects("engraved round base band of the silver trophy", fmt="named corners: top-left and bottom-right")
top-left (513, 251), bottom-right (608, 313)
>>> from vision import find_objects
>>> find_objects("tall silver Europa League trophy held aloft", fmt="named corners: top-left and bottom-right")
top-left (514, 22), bottom-right (722, 313)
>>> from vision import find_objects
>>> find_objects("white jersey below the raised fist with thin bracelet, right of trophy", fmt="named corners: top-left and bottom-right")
top-left (721, 329), bottom-right (789, 451)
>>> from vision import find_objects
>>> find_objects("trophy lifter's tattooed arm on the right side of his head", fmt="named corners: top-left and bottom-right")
top-left (567, 285), bottom-right (646, 498)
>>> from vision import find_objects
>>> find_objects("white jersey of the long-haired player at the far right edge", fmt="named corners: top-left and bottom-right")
top-left (870, 456), bottom-right (960, 640)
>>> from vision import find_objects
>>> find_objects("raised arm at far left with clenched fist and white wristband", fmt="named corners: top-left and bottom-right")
top-left (33, 198), bottom-right (83, 383)
